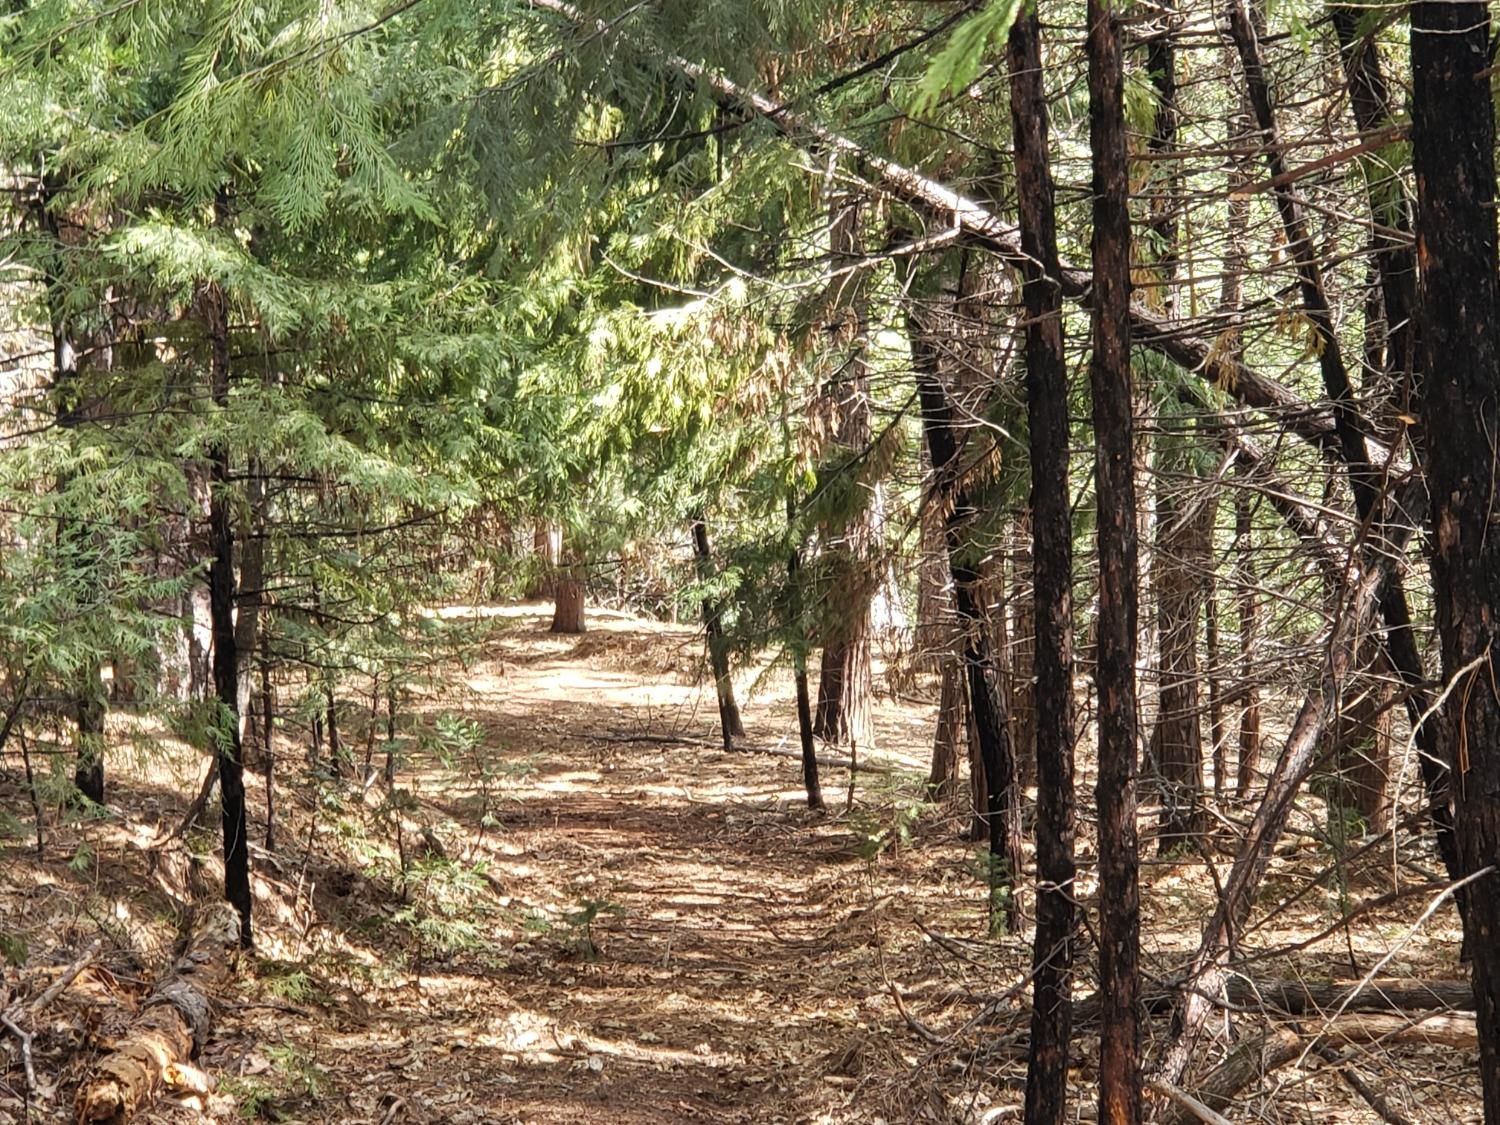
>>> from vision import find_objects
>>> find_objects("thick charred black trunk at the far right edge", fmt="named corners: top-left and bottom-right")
top-left (1412, 0), bottom-right (1500, 1122)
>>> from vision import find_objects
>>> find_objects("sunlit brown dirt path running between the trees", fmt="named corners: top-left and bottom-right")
top-left (208, 611), bottom-right (978, 1125)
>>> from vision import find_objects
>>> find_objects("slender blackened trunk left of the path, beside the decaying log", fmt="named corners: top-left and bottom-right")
top-left (198, 282), bottom-right (254, 950)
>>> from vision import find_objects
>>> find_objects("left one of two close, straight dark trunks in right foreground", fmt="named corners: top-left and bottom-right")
top-left (1007, 8), bottom-right (1077, 1125)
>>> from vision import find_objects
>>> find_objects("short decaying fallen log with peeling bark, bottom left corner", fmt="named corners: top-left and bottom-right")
top-left (74, 903), bottom-right (240, 1124)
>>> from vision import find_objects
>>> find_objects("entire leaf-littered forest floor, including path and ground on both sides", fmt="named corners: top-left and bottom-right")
top-left (0, 606), bottom-right (1479, 1125)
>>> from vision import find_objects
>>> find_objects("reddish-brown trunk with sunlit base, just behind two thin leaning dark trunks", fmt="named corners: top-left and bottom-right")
top-left (813, 198), bottom-right (881, 747)
